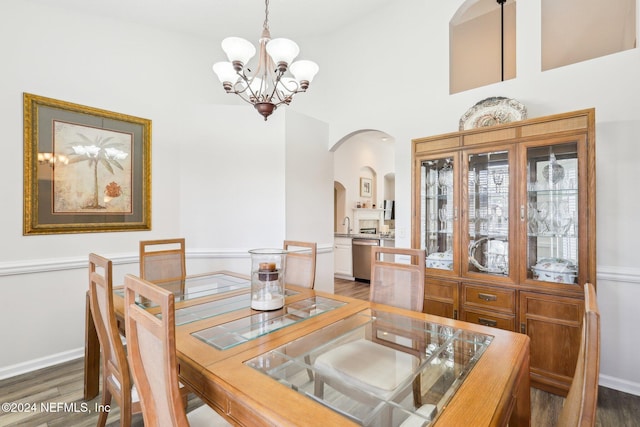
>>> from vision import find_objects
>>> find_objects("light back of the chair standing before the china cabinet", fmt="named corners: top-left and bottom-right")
top-left (369, 246), bottom-right (425, 311)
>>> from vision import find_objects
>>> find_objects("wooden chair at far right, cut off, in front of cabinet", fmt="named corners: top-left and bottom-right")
top-left (557, 283), bottom-right (600, 427)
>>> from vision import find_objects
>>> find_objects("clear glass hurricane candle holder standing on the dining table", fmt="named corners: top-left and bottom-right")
top-left (249, 249), bottom-right (287, 310)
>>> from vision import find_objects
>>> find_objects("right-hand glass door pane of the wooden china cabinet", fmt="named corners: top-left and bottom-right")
top-left (526, 142), bottom-right (579, 284)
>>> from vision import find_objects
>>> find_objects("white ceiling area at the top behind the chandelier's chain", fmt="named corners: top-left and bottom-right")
top-left (28, 0), bottom-right (391, 42)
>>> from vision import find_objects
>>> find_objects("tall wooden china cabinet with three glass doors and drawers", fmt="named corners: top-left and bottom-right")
top-left (412, 109), bottom-right (596, 394)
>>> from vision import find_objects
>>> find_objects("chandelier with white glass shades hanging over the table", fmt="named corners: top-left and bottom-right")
top-left (213, 0), bottom-right (318, 121)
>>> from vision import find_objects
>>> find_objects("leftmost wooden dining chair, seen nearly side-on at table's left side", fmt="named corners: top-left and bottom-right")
top-left (89, 253), bottom-right (142, 426)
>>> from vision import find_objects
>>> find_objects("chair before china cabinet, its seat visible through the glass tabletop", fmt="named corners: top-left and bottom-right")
top-left (314, 246), bottom-right (428, 423)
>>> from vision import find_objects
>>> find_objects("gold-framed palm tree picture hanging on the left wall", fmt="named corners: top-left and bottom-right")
top-left (23, 93), bottom-right (151, 235)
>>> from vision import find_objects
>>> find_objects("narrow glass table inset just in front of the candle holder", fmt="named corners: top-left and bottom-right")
top-left (192, 295), bottom-right (347, 350)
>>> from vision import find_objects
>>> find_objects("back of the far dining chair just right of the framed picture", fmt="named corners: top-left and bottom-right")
top-left (140, 238), bottom-right (187, 291)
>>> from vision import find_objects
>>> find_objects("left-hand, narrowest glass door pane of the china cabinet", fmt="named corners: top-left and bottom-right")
top-left (420, 157), bottom-right (457, 270)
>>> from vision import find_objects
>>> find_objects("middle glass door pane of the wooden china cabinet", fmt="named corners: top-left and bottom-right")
top-left (466, 150), bottom-right (511, 276)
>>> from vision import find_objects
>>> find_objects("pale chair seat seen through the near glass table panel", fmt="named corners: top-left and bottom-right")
top-left (314, 339), bottom-right (419, 399)
